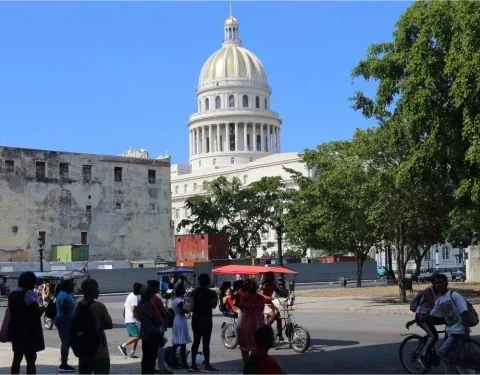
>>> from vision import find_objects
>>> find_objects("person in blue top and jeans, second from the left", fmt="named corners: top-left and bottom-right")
top-left (54, 279), bottom-right (75, 372)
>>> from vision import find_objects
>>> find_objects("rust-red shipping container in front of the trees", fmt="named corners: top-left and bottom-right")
top-left (175, 233), bottom-right (229, 263)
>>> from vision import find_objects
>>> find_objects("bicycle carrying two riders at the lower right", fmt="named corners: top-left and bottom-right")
top-left (399, 330), bottom-right (480, 374)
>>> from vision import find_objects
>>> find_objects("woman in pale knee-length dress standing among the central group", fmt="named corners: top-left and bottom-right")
top-left (172, 284), bottom-right (192, 369)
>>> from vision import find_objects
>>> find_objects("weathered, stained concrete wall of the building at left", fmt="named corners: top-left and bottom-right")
top-left (0, 147), bottom-right (172, 261)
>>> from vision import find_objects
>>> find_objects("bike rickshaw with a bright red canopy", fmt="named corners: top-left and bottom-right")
top-left (212, 265), bottom-right (310, 353)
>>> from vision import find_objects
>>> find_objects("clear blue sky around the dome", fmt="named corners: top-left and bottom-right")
top-left (0, 1), bottom-right (411, 163)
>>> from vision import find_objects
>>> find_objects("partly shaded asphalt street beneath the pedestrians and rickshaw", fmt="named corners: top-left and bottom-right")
top-left (0, 296), bottom-right (458, 374)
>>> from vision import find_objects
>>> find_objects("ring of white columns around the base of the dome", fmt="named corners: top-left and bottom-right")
top-left (189, 122), bottom-right (280, 157)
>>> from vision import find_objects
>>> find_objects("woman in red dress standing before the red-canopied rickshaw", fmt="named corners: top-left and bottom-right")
top-left (237, 279), bottom-right (265, 365)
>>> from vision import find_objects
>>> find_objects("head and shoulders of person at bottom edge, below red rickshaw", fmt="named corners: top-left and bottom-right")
top-left (243, 324), bottom-right (285, 374)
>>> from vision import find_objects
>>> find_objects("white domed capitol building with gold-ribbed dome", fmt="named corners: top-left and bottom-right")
top-left (171, 16), bottom-right (308, 256)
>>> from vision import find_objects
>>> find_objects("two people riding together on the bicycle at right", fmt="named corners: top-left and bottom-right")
top-left (406, 274), bottom-right (471, 374)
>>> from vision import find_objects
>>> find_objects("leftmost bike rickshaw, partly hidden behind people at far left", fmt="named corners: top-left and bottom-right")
top-left (35, 271), bottom-right (89, 330)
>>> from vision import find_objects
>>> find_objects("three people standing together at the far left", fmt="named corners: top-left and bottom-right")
top-left (8, 272), bottom-right (113, 374)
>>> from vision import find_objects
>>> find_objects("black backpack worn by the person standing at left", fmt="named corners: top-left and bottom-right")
top-left (70, 302), bottom-right (102, 358)
